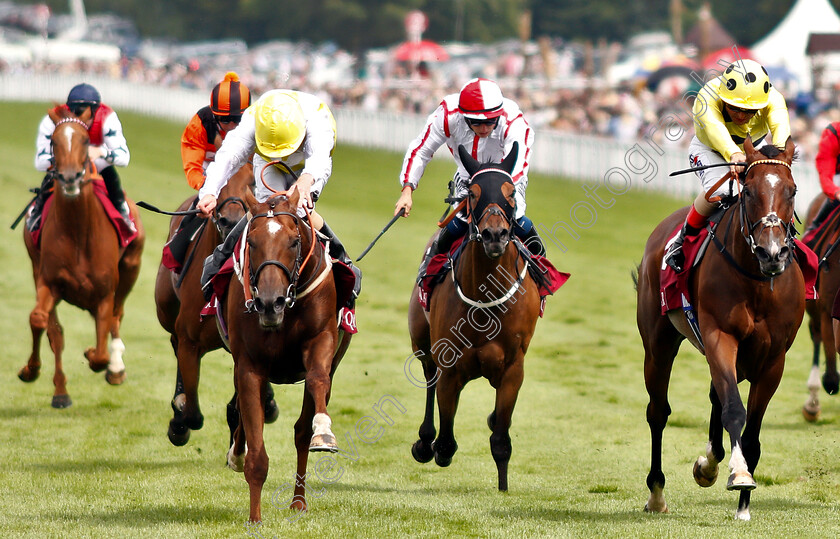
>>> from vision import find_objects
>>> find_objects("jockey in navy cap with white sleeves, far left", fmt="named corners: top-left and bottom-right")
top-left (26, 83), bottom-right (134, 230)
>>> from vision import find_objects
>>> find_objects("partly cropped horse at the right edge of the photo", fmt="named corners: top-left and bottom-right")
top-left (802, 193), bottom-right (840, 421)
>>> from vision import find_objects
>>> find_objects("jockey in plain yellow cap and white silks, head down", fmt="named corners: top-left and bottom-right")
top-left (198, 90), bottom-right (362, 310)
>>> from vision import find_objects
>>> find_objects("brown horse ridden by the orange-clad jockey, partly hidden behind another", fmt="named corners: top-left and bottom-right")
top-left (155, 163), bottom-right (278, 446)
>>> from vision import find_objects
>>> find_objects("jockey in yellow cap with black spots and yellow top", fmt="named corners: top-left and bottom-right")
top-left (665, 60), bottom-right (790, 273)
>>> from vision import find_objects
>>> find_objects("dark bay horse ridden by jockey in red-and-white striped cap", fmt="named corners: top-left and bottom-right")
top-left (408, 144), bottom-right (540, 491)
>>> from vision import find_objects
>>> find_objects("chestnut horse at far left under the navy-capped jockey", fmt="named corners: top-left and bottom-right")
top-left (18, 106), bottom-right (145, 408)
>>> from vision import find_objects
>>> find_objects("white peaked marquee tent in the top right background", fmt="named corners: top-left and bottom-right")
top-left (751, 0), bottom-right (840, 91)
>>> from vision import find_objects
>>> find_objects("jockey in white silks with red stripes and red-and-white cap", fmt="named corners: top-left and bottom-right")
top-left (394, 78), bottom-right (545, 281)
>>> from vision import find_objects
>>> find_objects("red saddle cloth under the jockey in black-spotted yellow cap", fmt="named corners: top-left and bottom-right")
top-left (659, 224), bottom-right (819, 315)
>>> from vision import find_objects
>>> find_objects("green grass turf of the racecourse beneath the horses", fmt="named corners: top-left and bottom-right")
top-left (0, 103), bottom-right (840, 538)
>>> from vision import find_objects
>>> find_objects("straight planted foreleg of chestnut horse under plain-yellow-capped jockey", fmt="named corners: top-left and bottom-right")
top-left (236, 361), bottom-right (268, 522)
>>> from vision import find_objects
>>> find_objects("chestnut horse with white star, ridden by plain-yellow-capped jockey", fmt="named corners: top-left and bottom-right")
top-left (223, 190), bottom-right (350, 522)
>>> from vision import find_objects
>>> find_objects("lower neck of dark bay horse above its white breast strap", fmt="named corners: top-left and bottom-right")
top-left (455, 241), bottom-right (522, 297)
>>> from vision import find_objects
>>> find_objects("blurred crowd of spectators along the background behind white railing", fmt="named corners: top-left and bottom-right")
top-left (0, 44), bottom-right (840, 165)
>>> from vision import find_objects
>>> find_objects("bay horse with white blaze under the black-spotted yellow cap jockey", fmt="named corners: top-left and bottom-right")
top-left (636, 138), bottom-right (805, 520)
